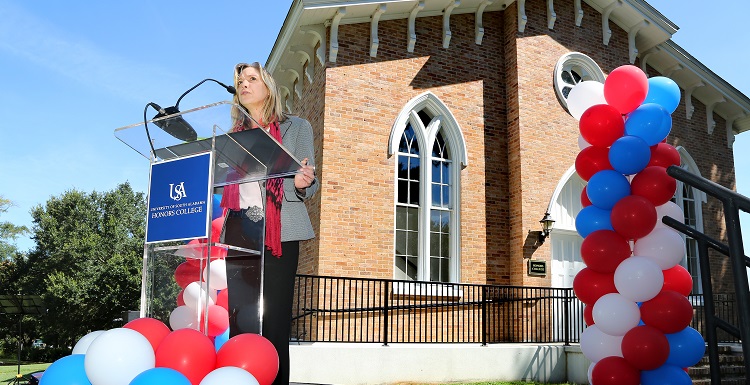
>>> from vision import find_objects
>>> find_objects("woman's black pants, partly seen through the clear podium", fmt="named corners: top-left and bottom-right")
top-left (222, 212), bottom-right (299, 385)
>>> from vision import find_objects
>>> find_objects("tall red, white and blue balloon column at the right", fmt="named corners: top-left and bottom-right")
top-left (568, 65), bottom-right (705, 385)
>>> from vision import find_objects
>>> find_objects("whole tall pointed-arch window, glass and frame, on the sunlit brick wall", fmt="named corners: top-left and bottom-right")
top-left (389, 92), bottom-right (466, 282)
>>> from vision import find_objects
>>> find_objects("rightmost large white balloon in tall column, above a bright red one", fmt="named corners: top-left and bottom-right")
top-left (633, 227), bottom-right (685, 270)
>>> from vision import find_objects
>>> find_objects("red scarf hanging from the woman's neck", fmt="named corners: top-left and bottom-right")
top-left (220, 121), bottom-right (284, 258)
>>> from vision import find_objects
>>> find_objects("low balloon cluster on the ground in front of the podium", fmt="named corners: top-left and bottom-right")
top-left (40, 318), bottom-right (279, 385)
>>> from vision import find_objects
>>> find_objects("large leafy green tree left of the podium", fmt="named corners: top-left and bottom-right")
top-left (20, 183), bottom-right (146, 346)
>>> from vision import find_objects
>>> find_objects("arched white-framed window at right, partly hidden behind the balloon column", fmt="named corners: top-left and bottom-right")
top-left (673, 146), bottom-right (706, 294)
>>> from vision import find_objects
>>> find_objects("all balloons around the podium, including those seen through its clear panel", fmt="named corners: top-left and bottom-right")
top-left (40, 196), bottom-right (279, 385)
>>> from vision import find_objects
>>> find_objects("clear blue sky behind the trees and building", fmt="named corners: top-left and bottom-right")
top-left (0, 0), bottom-right (750, 250)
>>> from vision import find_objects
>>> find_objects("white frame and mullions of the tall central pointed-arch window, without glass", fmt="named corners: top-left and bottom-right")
top-left (388, 91), bottom-right (468, 283)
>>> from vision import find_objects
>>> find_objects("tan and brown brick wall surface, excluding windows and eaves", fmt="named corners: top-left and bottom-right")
top-left (295, 0), bottom-right (735, 292)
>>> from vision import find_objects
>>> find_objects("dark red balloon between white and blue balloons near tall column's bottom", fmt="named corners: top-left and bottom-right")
top-left (621, 325), bottom-right (669, 370)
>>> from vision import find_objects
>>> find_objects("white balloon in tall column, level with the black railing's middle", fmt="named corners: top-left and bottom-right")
top-left (591, 293), bottom-right (641, 336)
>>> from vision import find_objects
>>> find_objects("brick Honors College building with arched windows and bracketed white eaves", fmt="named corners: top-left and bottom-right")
top-left (266, 0), bottom-right (750, 304)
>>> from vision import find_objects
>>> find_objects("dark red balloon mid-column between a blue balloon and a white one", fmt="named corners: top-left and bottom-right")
top-left (610, 195), bottom-right (656, 240)
